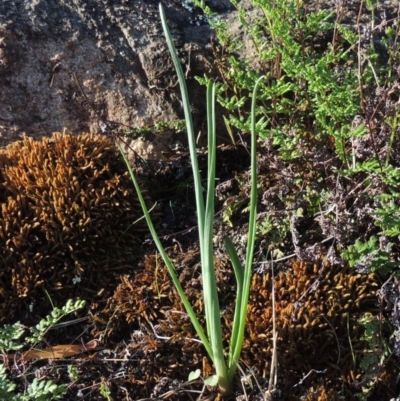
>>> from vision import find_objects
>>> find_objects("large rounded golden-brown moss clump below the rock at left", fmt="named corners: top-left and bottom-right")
top-left (0, 134), bottom-right (149, 321)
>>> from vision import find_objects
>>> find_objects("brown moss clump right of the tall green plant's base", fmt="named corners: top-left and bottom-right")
top-left (244, 260), bottom-right (378, 385)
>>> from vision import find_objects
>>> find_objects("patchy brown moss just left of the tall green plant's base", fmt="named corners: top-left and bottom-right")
top-left (92, 246), bottom-right (235, 399)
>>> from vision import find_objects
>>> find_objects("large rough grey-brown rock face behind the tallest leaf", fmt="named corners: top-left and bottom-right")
top-left (0, 0), bottom-right (222, 146)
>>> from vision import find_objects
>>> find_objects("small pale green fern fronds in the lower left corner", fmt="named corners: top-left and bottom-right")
top-left (0, 299), bottom-right (85, 401)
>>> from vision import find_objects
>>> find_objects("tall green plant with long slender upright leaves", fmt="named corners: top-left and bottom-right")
top-left (119, 4), bottom-right (262, 394)
